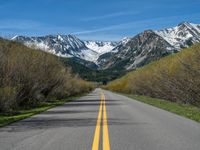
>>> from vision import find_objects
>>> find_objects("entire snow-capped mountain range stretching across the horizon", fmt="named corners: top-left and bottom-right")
top-left (12, 22), bottom-right (200, 70)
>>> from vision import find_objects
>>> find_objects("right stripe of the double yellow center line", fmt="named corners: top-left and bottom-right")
top-left (102, 93), bottom-right (110, 150)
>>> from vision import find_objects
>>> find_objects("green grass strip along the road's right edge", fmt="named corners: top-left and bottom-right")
top-left (126, 94), bottom-right (200, 122)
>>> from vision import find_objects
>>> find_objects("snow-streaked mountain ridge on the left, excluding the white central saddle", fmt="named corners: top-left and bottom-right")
top-left (12, 35), bottom-right (99, 61)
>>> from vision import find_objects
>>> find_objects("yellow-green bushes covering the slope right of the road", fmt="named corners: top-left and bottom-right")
top-left (106, 44), bottom-right (200, 107)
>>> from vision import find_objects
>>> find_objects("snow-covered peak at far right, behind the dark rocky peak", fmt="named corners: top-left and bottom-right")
top-left (154, 22), bottom-right (200, 50)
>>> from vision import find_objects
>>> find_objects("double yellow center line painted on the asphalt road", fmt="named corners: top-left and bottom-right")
top-left (92, 93), bottom-right (110, 150)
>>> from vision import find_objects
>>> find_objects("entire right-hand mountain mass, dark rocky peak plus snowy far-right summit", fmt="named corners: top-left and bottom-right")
top-left (97, 22), bottom-right (200, 70)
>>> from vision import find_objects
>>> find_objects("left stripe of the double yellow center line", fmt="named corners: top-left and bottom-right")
top-left (92, 92), bottom-right (103, 150)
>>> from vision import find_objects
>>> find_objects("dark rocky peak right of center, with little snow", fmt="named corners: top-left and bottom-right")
top-left (98, 30), bottom-right (176, 70)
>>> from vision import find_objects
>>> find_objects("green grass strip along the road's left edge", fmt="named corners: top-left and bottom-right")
top-left (0, 96), bottom-right (83, 127)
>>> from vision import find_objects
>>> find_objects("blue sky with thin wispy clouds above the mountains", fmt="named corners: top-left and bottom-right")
top-left (0, 0), bottom-right (200, 41)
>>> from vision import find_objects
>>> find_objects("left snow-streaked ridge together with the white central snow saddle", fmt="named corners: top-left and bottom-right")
top-left (12, 35), bottom-right (118, 63)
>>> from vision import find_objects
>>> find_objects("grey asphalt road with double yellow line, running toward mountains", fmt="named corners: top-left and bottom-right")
top-left (0, 89), bottom-right (200, 150)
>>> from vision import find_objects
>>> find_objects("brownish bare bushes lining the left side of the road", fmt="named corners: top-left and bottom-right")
top-left (0, 39), bottom-right (93, 115)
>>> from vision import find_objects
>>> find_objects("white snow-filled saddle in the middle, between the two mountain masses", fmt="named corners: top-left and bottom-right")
top-left (84, 41), bottom-right (118, 55)
